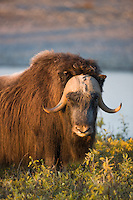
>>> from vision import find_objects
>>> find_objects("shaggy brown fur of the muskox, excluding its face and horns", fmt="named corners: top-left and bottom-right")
top-left (0, 51), bottom-right (104, 166)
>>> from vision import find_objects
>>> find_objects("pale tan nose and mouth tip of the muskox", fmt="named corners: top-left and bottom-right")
top-left (73, 125), bottom-right (93, 137)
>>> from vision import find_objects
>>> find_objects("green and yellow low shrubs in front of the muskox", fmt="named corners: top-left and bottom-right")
top-left (0, 118), bottom-right (133, 200)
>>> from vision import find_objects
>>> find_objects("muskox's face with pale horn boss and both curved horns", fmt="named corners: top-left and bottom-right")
top-left (43, 75), bottom-right (122, 137)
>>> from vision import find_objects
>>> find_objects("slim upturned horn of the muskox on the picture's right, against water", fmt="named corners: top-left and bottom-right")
top-left (99, 95), bottom-right (122, 113)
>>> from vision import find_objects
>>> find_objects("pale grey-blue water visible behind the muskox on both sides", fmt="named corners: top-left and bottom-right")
top-left (0, 66), bottom-right (133, 137)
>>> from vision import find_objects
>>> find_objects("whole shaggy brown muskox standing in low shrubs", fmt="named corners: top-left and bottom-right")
top-left (0, 51), bottom-right (121, 166)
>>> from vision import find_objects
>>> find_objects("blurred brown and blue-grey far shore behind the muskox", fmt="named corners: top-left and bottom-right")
top-left (0, 0), bottom-right (133, 71)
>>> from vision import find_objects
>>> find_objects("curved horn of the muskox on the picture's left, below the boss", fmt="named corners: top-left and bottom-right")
top-left (43, 93), bottom-right (67, 113)
